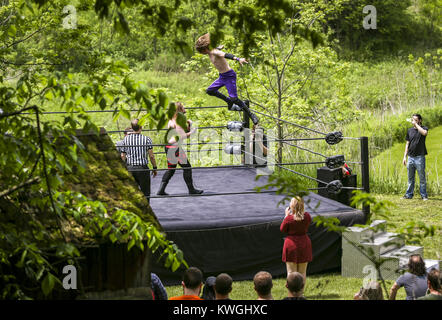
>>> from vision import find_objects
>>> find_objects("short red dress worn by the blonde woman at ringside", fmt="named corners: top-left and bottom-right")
top-left (280, 212), bottom-right (313, 263)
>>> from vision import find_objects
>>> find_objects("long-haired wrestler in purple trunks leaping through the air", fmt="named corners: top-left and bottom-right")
top-left (195, 33), bottom-right (259, 125)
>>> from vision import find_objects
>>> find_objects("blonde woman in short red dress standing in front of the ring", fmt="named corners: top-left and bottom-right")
top-left (280, 197), bottom-right (312, 282)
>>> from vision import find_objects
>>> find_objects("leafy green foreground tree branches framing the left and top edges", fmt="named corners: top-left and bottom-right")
top-left (0, 0), bottom-right (322, 299)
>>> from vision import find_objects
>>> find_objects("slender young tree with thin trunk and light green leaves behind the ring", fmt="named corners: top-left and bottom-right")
top-left (235, 6), bottom-right (353, 163)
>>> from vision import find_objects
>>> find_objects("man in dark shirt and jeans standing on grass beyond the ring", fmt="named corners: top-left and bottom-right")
top-left (402, 114), bottom-right (428, 200)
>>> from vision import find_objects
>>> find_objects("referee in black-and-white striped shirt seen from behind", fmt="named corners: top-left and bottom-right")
top-left (122, 119), bottom-right (157, 202)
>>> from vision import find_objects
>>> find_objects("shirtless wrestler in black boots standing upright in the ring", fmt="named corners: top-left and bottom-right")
top-left (157, 102), bottom-right (203, 195)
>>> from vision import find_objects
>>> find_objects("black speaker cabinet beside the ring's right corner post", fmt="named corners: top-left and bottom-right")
top-left (316, 167), bottom-right (357, 206)
